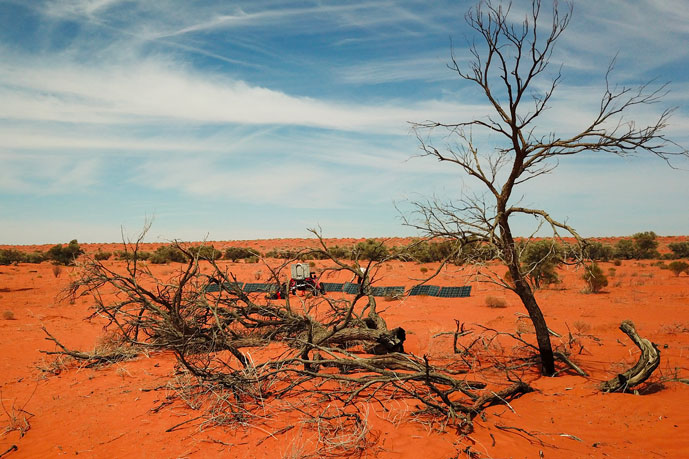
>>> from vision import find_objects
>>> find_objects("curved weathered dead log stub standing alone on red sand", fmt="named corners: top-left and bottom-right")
top-left (600, 320), bottom-right (660, 392)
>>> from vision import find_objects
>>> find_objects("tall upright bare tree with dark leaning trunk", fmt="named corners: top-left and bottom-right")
top-left (407, 0), bottom-right (687, 375)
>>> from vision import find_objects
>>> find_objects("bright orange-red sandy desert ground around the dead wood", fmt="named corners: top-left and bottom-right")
top-left (0, 239), bottom-right (689, 459)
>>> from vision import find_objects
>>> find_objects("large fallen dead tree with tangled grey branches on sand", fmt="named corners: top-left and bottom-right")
top-left (47, 232), bottom-right (531, 429)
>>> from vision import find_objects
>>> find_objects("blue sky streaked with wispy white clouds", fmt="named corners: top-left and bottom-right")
top-left (0, 0), bottom-right (689, 244)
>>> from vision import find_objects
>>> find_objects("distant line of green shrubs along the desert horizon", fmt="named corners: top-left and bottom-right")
top-left (0, 231), bottom-right (689, 266)
